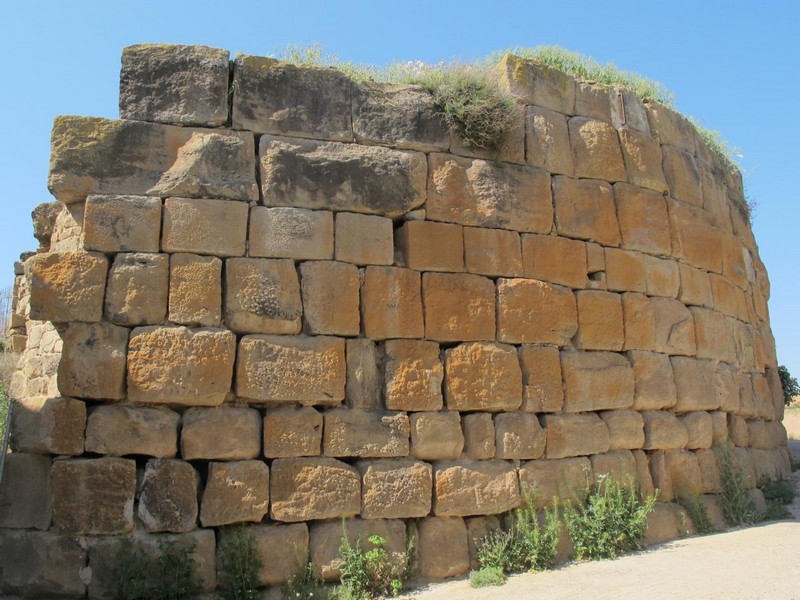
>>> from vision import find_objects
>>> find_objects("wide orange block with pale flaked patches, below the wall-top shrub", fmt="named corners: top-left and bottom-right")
top-left (426, 153), bottom-right (553, 233)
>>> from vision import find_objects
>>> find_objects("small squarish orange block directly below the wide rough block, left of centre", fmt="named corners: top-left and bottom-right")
top-left (264, 406), bottom-right (322, 458)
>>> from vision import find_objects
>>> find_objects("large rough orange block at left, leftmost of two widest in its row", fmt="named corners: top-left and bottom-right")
top-left (128, 327), bottom-right (236, 406)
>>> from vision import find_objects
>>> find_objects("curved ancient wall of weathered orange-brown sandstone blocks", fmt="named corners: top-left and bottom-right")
top-left (0, 46), bottom-right (789, 598)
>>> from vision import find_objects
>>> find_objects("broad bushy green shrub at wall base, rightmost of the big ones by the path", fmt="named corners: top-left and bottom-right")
top-left (564, 476), bottom-right (656, 560)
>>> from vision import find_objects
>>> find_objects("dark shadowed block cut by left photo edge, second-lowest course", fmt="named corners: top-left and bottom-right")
top-left (0, 452), bottom-right (53, 528)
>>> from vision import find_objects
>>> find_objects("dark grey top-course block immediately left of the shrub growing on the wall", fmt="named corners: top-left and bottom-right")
top-left (353, 82), bottom-right (450, 152)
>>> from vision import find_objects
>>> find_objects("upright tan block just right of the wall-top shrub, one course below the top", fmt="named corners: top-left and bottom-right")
top-left (525, 106), bottom-right (573, 176)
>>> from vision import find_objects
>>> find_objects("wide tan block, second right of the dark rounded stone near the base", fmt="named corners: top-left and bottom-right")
top-left (270, 458), bottom-right (361, 522)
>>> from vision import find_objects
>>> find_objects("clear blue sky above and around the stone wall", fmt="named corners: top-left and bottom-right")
top-left (0, 0), bottom-right (800, 376)
